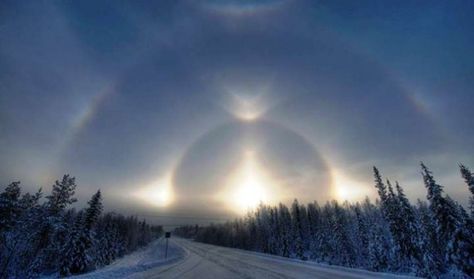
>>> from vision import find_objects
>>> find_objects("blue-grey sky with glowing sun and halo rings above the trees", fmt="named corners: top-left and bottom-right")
top-left (0, 0), bottom-right (474, 223)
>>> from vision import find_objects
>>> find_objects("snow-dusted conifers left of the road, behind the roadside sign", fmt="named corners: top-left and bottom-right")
top-left (0, 175), bottom-right (162, 278)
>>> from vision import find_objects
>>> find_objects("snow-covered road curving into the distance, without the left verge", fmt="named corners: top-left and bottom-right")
top-left (128, 238), bottom-right (410, 279)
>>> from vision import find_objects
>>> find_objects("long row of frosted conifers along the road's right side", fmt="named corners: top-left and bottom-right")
top-left (176, 164), bottom-right (474, 278)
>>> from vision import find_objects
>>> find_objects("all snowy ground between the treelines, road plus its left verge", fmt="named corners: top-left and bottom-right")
top-left (66, 238), bottom-right (418, 279)
